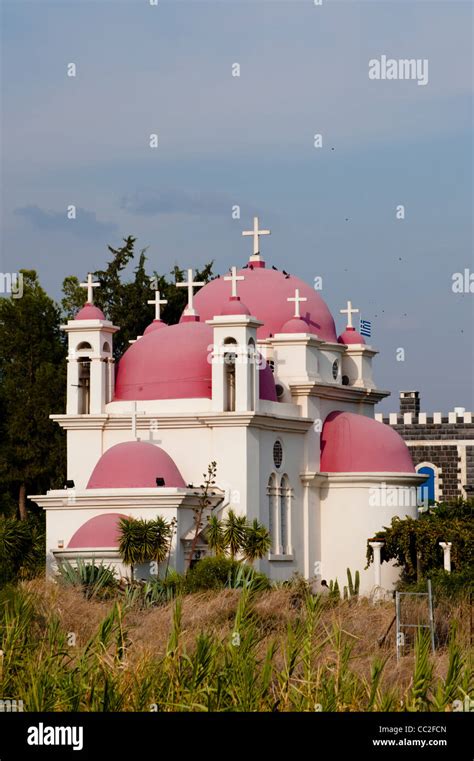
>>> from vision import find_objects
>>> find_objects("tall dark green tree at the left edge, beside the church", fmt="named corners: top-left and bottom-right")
top-left (0, 270), bottom-right (66, 520)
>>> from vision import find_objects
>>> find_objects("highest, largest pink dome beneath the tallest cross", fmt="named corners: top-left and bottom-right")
top-left (194, 267), bottom-right (337, 342)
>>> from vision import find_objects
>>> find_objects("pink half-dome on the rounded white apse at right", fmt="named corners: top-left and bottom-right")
top-left (320, 412), bottom-right (415, 473)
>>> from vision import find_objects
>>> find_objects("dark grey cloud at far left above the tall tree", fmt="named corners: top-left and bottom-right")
top-left (14, 205), bottom-right (117, 238)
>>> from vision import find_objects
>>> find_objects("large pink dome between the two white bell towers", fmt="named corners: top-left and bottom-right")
top-left (114, 321), bottom-right (276, 401)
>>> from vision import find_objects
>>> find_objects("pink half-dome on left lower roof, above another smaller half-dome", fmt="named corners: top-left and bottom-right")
top-left (87, 441), bottom-right (186, 489)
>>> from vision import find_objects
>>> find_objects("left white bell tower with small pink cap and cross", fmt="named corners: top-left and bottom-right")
top-left (61, 273), bottom-right (119, 415)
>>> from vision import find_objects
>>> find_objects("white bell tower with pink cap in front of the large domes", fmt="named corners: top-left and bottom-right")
top-left (207, 267), bottom-right (263, 412)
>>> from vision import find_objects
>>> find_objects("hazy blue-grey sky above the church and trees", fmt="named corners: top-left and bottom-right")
top-left (0, 0), bottom-right (474, 412)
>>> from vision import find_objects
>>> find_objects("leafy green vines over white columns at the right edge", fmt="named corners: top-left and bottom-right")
top-left (367, 503), bottom-right (474, 582)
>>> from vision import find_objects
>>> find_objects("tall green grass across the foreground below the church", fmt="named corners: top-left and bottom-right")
top-left (0, 585), bottom-right (474, 712)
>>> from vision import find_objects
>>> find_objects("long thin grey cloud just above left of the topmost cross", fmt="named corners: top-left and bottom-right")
top-left (120, 188), bottom-right (232, 216)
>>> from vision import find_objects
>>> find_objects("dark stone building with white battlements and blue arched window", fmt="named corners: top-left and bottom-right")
top-left (375, 391), bottom-right (474, 502)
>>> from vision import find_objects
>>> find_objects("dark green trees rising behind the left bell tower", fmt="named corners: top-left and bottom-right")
top-left (61, 235), bottom-right (213, 359)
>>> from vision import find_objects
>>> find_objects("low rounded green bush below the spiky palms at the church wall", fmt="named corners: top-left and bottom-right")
top-left (186, 556), bottom-right (270, 592)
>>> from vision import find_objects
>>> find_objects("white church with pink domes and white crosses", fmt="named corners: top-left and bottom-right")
top-left (30, 218), bottom-right (425, 594)
